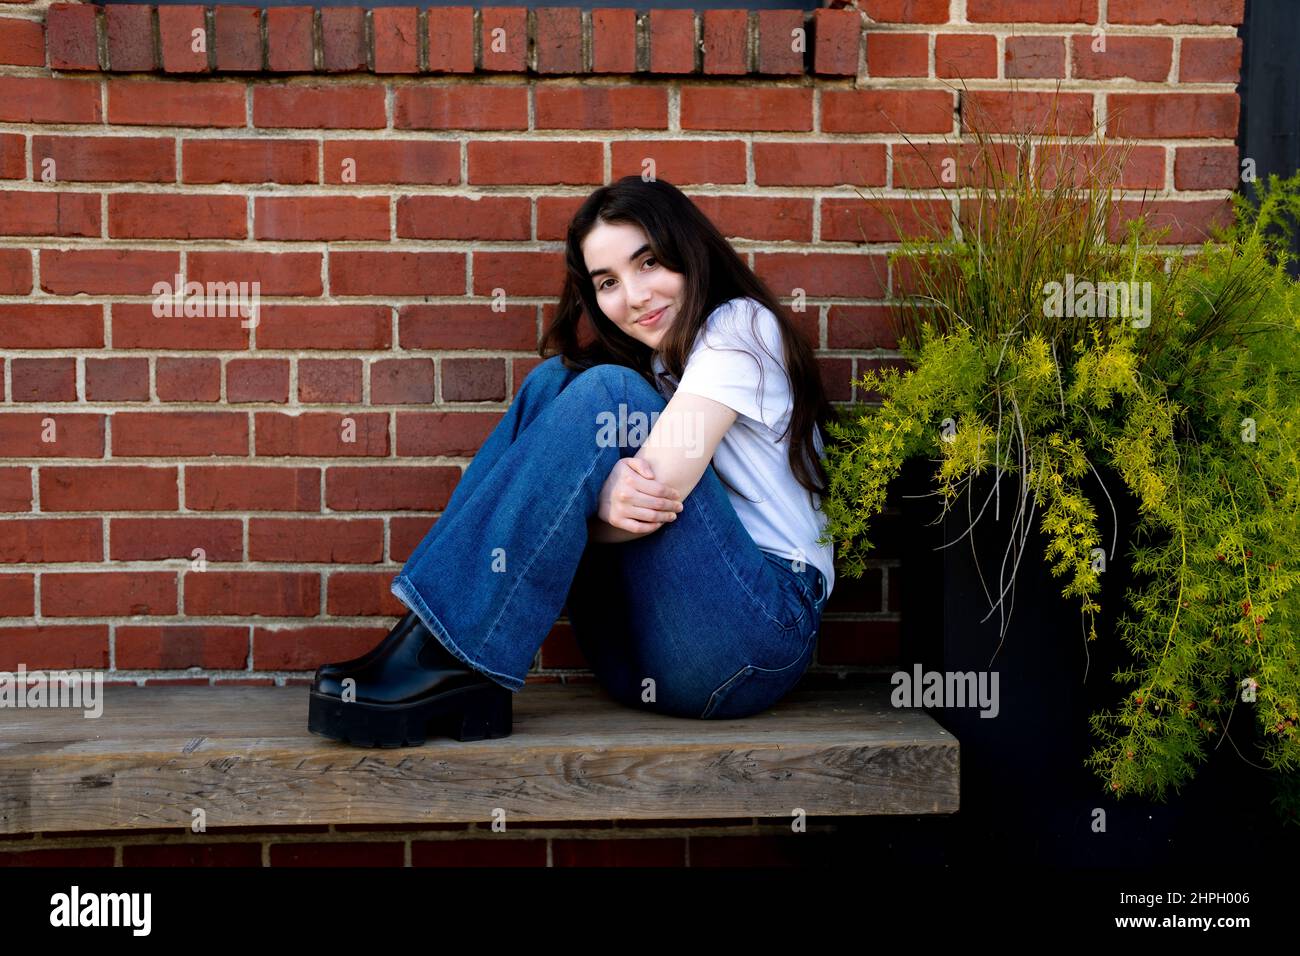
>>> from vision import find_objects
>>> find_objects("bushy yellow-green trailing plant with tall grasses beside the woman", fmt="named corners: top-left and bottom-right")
top-left (823, 121), bottom-right (1300, 821)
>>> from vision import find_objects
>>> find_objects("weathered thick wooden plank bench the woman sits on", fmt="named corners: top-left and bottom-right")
top-left (0, 683), bottom-right (958, 834)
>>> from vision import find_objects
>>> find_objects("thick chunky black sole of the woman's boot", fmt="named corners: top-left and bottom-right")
top-left (307, 684), bottom-right (515, 747)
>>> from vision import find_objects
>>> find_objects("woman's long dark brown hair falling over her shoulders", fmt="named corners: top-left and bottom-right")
top-left (538, 176), bottom-right (833, 497)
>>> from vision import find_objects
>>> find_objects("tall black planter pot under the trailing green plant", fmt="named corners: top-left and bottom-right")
top-left (900, 459), bottom-right (1295, 866)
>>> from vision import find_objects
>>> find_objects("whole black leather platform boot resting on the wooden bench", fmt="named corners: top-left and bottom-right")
top-left (307, 613), bottom-right (514, 747)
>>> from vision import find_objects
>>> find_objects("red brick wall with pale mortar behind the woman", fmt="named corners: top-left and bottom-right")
top-left (0, 0), bottom-right (1243, 697)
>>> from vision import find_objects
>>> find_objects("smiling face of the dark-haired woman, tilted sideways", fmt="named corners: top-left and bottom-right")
top-left (582, 222), bottom-right (686, 351)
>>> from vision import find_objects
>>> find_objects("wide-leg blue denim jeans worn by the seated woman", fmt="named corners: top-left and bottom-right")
top-left (391, 356), bottom-right (826, 718)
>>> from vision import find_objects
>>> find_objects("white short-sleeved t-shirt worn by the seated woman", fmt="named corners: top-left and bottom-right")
top-left (651, 298), bottom-right (835, 597)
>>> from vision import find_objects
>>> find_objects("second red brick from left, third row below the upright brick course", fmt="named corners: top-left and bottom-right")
top-left (108, 193), bottom-right (248, 239)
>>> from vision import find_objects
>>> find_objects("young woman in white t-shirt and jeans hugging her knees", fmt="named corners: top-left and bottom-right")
top-left (308, 176), bottom-right (835, 747)
